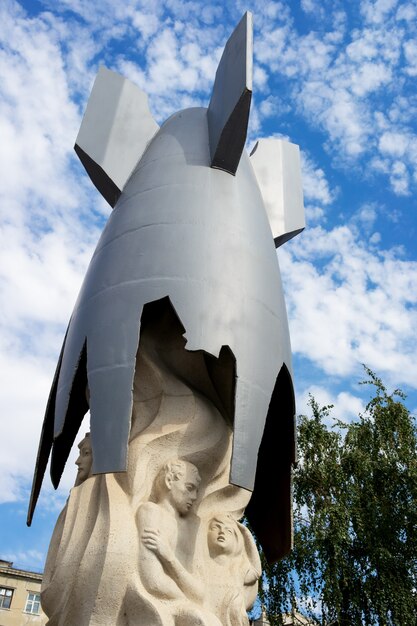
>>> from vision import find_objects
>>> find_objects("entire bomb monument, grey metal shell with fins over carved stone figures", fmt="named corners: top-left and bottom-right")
top-left (28, 13), bottom-right (304, 626)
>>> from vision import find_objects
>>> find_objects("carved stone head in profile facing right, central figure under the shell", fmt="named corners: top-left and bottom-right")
top-left (154, 459), bottom-right (201, 516)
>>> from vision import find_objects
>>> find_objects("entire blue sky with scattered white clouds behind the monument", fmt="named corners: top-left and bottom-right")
top-left (0, 0), bottom-right (417, 569)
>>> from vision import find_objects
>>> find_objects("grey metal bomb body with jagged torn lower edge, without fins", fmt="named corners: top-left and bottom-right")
top-left (54, 109), bottom-right (291, 482)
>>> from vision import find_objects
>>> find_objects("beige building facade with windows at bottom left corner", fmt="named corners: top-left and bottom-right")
top-left (0, 559), bottom-right (48, 626)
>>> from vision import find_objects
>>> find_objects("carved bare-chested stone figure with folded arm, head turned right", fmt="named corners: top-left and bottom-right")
top-left (136, 459), bottom-right (203, 604)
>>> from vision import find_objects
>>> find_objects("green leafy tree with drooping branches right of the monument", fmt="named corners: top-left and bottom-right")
top-left (260, 369), bottom-right (417, 626)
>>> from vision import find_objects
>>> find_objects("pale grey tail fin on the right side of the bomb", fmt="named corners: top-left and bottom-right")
top-left (251, 138), bottom-right (305, 248)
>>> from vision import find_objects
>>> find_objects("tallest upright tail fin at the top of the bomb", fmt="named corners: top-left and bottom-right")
top-left (207, 12), bottom-right (253, 174)
